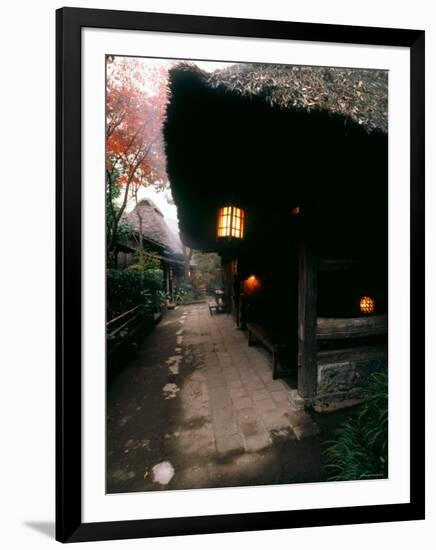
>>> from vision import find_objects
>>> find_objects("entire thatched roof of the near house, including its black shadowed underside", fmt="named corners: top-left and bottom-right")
top-left (164, 63), bottom-right (388, 251)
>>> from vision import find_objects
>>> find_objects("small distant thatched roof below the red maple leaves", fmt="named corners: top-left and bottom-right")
top-left (124, 199), bottom-right (183, 255)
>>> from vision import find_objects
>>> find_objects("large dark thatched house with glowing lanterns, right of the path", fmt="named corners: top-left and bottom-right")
top-left (165, 63), bottom-right (388, 409)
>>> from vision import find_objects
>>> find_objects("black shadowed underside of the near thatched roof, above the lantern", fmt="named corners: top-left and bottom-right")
top-left (165, 65), bottom-right (387, 251)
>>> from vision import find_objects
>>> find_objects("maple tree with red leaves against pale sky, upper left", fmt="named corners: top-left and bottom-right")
top-left (106, 56), bottom-right (169, 260)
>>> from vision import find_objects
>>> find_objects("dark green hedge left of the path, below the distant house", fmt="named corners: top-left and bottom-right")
top-left (106, 269), bottom-right (164, 320)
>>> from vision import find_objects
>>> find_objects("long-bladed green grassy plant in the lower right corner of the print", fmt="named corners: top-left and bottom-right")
top-left (326, 370), bottom-right (388, 481)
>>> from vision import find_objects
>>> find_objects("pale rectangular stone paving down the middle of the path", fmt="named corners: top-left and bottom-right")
top-left (183, 307), bottom-right (312, 455)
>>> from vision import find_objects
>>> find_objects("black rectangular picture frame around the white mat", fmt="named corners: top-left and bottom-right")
top-left (56, 8), bottom-right (425, 542)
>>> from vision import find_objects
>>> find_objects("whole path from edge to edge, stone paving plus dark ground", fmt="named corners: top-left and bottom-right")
top-left (107, 304), bottom-right (336, 492)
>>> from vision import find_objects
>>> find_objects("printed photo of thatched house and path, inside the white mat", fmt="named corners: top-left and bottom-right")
top-left (105, 53), bottom-right (389, 494)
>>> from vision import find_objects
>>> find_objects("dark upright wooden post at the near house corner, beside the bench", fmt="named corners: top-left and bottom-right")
top-left (298, 240), bottom-right (318, 398)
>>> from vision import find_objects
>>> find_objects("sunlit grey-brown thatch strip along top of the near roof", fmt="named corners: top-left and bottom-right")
top-left (174, 63), bottom-right (388, 133)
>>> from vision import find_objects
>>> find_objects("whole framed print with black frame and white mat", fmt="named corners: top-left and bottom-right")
top-left (56, 8), bottom-right (425, 542)
